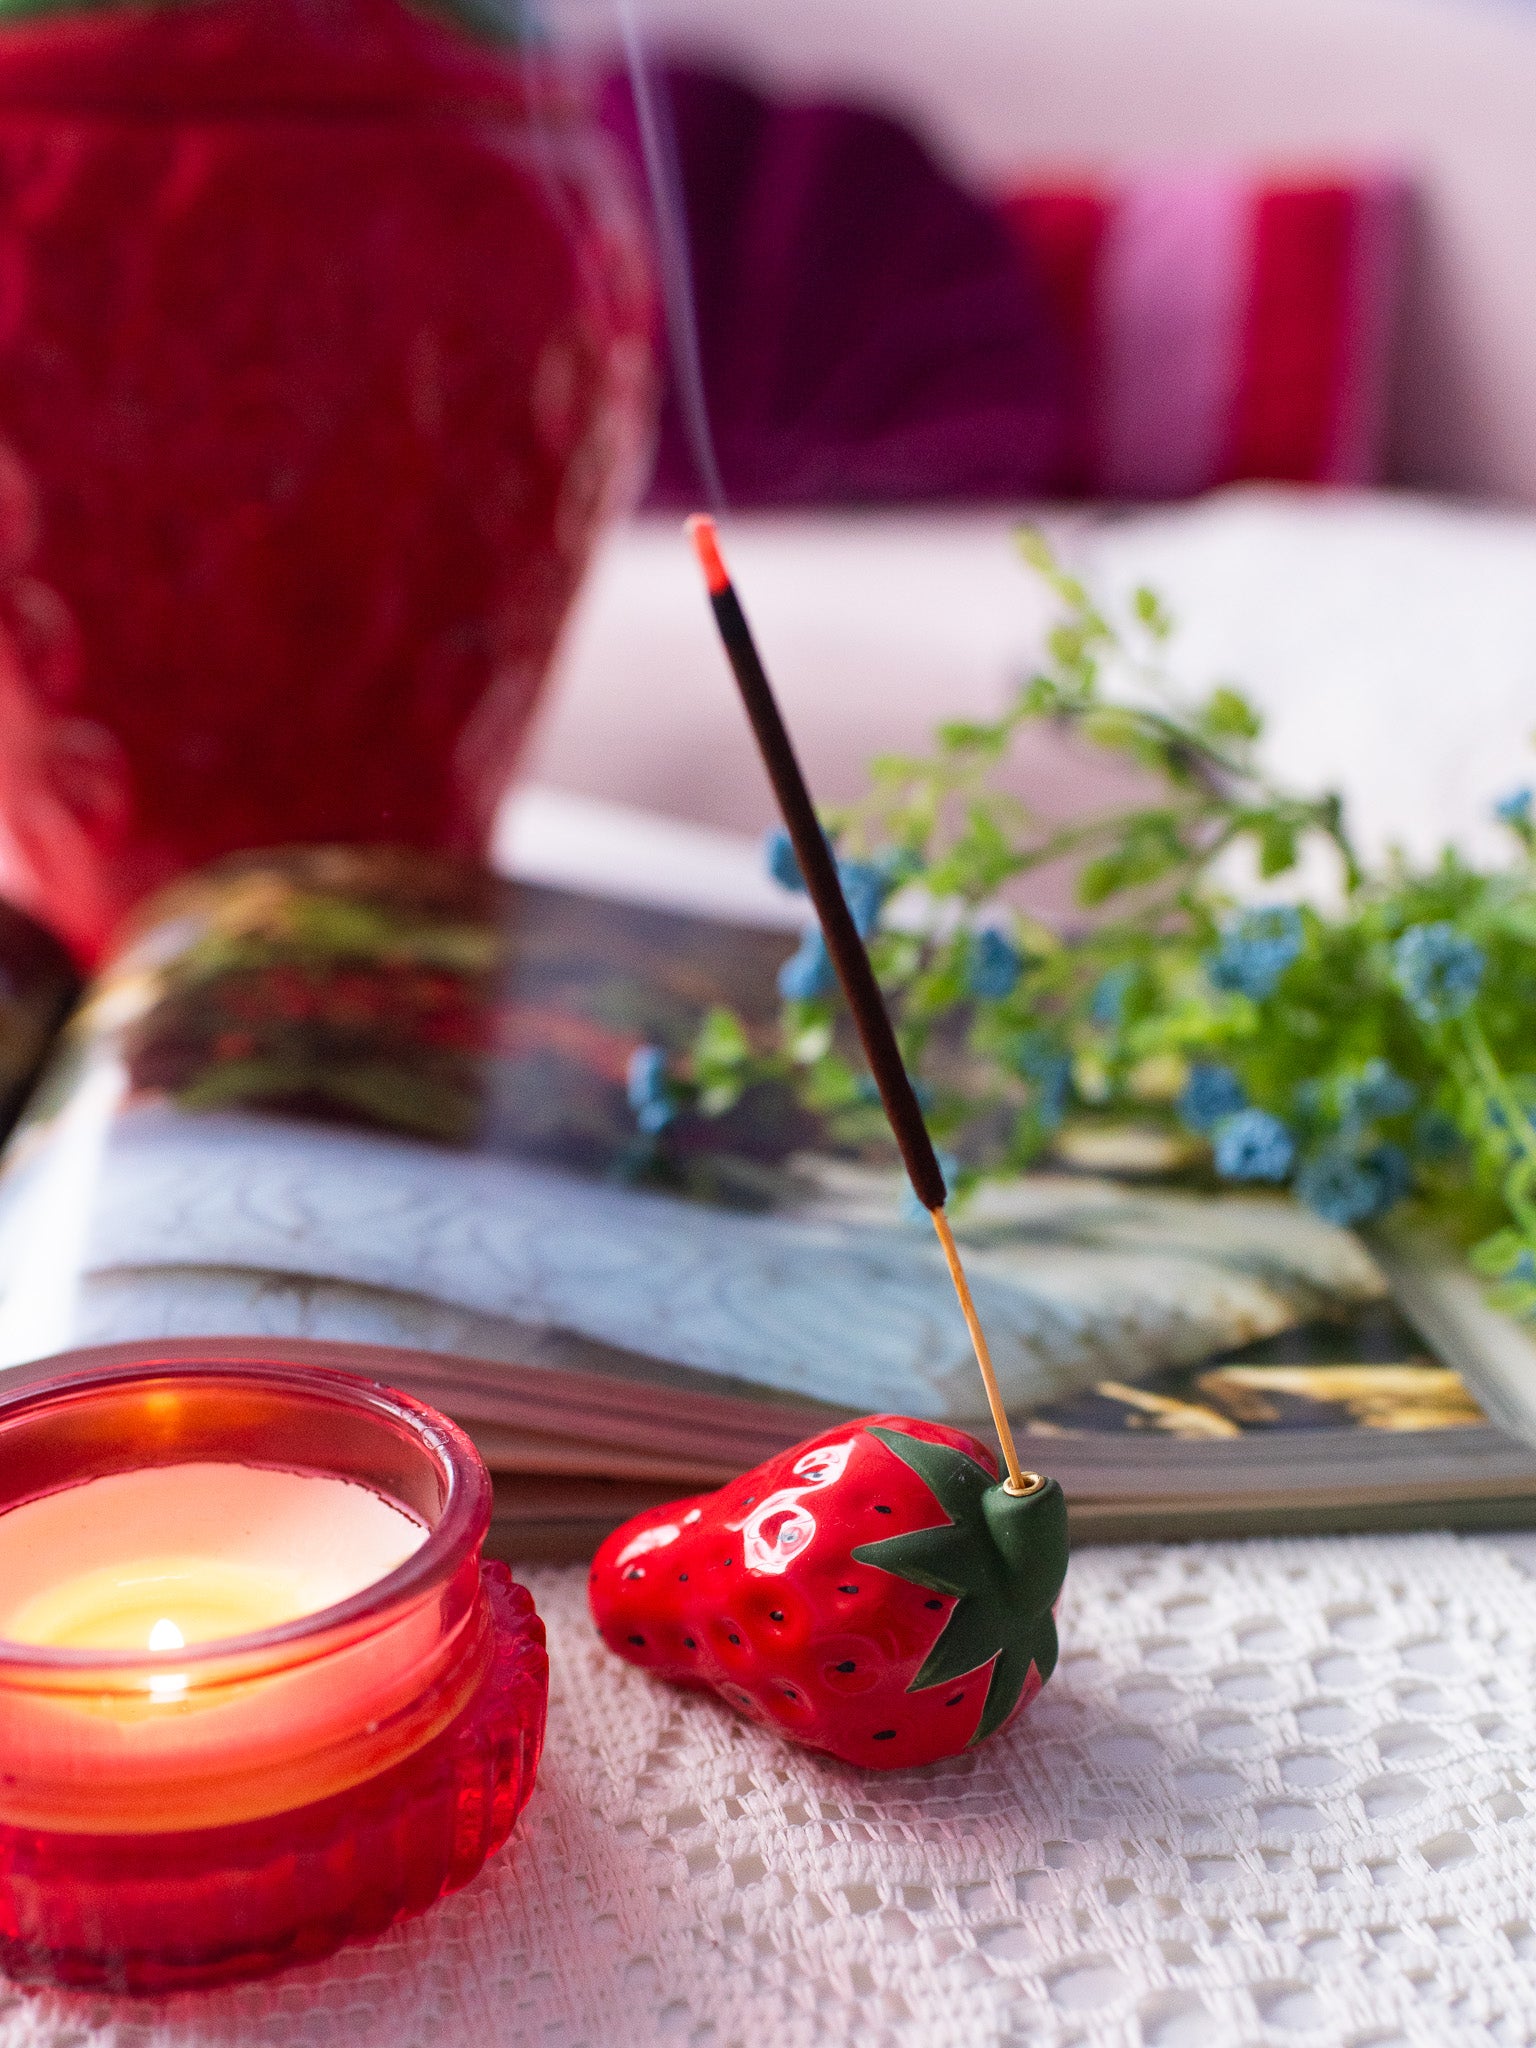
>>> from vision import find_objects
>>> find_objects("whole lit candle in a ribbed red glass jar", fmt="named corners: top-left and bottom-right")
top-left (0, 1348), bottom-right (549, 1991)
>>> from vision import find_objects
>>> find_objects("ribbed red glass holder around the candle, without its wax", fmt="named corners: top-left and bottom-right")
top-left (0, 1346), bottom-right (549, 1993)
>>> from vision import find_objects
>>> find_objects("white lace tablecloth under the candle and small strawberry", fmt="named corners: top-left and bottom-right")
top-left (0, 1536), bottom-right (1536, 2048)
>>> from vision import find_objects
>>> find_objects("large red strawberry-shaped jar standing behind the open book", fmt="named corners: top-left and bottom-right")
top-left (0, 0), bottom-right (651, 954)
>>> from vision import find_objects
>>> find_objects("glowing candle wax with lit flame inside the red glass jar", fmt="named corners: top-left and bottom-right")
top-left (0, 1460), bottom-right (462, 1833)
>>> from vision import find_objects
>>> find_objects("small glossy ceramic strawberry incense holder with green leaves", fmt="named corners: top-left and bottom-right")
top-left (590, 1415), bottom-right (1067, 1769)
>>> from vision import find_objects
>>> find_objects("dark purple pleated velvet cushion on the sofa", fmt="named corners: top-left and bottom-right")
top-left (604, 68), bottom-right (1069, 506)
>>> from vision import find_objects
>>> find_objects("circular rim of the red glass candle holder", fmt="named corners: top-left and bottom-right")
top-left (0, 1339), bottom-right (492, 1679)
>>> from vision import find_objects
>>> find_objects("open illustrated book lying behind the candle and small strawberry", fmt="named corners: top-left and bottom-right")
top-left (0, 827), bottom-right (1536, 1556)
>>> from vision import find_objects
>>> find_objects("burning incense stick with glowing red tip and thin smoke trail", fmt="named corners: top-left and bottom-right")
top-left (688, 514), bottom-right (1044, 1493)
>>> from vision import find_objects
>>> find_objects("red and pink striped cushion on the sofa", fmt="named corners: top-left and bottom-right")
top-left (997, 168), bottom-right (1411, 498)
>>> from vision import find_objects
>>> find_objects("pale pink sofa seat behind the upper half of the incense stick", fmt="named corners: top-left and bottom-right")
top-left (524, 510), bottom-right (1089, 851)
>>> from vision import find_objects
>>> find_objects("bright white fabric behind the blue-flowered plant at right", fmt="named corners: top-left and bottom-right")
top-left (1085, 489), bottom-right (1536, 884)
